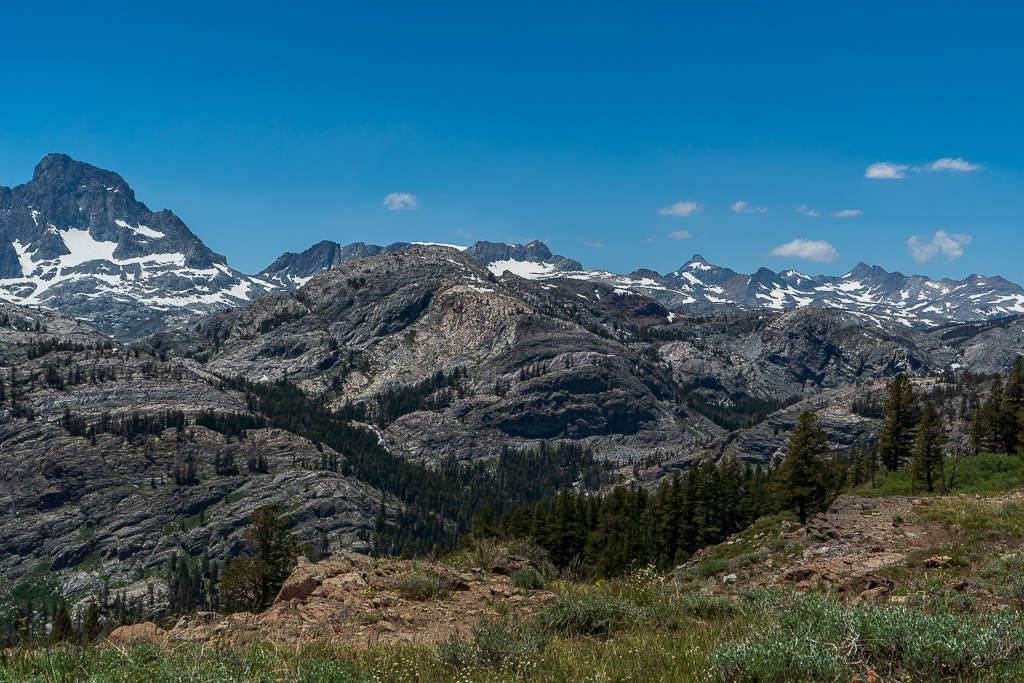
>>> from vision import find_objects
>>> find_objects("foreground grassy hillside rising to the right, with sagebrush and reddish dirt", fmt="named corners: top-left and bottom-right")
top-left (6, 492), bottom-right (1024, 683)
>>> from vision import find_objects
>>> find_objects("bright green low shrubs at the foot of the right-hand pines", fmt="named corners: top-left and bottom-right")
top-left (851, 453), bottom-right (1024, 497)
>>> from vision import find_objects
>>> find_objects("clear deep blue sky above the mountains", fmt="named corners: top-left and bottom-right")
top-left (0, 2), bottom-right (1024, 282)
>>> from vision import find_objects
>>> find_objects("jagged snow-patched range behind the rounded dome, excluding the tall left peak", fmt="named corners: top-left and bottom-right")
top-left (259, 241), bottom-right (1024, 328)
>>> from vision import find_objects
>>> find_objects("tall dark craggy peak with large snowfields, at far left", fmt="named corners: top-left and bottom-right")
top-left (0, 154), bottom-right (269, 339)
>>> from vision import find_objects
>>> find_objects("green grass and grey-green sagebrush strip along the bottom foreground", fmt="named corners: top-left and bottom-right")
top-left (8, 589), bottom-right (1024, 683)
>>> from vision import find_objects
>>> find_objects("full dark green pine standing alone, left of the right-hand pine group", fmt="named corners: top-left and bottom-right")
top-left (774, 411), bottom-right (831, 524)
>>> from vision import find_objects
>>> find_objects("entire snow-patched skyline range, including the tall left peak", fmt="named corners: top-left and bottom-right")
top-left (0, 154), bottom-right (1024, 339)
